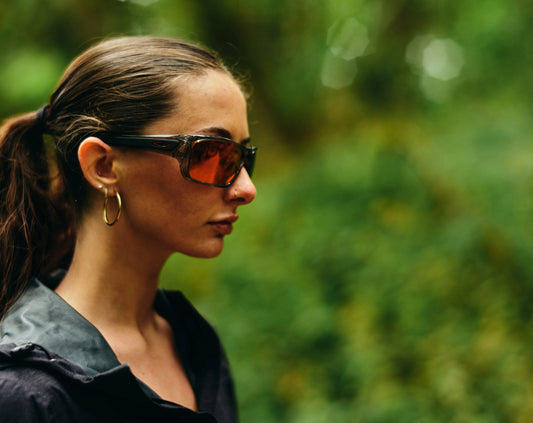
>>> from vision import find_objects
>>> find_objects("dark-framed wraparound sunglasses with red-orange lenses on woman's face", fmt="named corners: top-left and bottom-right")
top-left (100, 133), bottom-right (257, 188)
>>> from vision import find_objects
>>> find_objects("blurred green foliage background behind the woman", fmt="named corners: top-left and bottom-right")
top-left (0, 0), bottom-right (533, 423)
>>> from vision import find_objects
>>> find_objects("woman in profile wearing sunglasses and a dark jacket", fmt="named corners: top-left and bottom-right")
top-left (0, 37), bottom-right (256, 423)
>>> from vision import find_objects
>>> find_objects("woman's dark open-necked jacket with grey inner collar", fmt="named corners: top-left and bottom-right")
top-left (0, 279), bottom-right (237, 423)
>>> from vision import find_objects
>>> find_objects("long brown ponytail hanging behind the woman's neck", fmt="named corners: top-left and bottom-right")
top-left (0, 109), bottom-right (72, 319)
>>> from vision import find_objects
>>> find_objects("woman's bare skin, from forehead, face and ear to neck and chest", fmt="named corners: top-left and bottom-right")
top-left (56, 71), bottom-right (256, 410)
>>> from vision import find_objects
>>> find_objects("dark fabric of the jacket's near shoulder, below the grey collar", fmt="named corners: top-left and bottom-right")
top-left (0, 343), bottom-right (202, 423)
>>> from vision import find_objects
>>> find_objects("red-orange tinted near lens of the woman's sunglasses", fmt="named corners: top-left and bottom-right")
top-left (189, 139), bottom-right (242, 186)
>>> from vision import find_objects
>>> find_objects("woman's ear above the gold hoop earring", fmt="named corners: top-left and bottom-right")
top-left (78, 137), bottom-right (118, 188)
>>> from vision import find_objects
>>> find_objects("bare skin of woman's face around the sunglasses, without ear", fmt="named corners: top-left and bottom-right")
top-left (116, 70), bottom-right (256, 257)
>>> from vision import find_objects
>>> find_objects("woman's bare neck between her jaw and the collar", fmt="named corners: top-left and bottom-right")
top-left (56, 212), bottom-right (168, 333)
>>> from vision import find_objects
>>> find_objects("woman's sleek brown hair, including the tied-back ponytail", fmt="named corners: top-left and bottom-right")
top-left (0, 37), bottom-right (233, 318)
